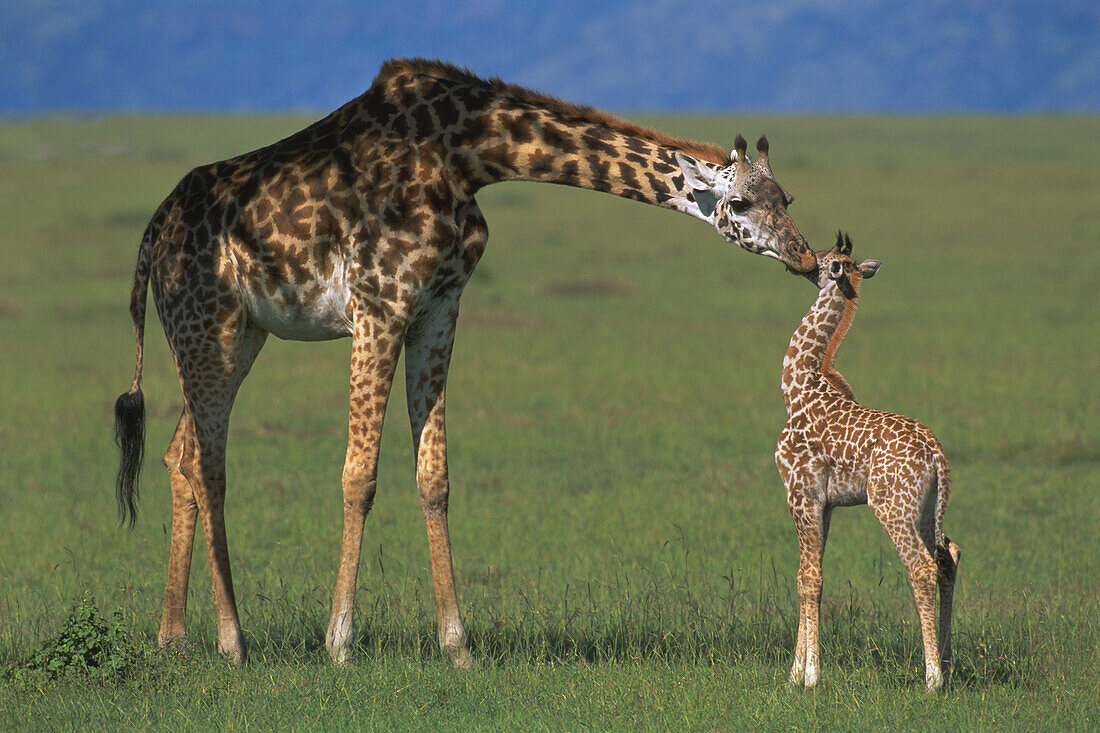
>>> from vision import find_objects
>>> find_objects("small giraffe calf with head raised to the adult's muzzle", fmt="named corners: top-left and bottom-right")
top-left (776, 234), bottom-right (960, 692)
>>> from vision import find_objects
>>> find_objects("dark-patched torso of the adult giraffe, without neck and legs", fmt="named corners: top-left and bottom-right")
top-left (141, 83), bottom-right (480, 340)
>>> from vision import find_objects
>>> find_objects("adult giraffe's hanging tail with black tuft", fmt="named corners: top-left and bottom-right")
top-left (114, 225), bottom-right (152, 528)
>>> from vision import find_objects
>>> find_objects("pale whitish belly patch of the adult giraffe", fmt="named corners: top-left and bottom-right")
top-left (244, 278), bottom-right (352, 341)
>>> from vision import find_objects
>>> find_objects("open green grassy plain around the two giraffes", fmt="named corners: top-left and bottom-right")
top-left (0, 117), bottom-right (1100, 731)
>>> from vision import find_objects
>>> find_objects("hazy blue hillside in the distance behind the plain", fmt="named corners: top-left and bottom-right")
top-left (0, 0), bottom-right (1100, 114)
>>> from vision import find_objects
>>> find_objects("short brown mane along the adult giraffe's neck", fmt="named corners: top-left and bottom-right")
top-left (374, 58), bottom-right (729, 166)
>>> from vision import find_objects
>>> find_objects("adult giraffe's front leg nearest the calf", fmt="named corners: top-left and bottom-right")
top-left (405, 297), bottom-right (474, 669)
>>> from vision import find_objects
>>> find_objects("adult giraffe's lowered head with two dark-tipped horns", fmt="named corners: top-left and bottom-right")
top-left (677, 135), bottom-right (816, 274)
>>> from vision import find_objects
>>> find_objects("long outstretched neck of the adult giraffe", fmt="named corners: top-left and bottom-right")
top-left (369, 59), bottom-right (729, 218)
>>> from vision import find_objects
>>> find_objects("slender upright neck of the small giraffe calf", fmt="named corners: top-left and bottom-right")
top-left (782, 275), bottom-right (859, 412)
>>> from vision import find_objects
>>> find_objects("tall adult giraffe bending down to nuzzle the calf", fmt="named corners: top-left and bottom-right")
top-left (116, 59), bottom-right (814, 667)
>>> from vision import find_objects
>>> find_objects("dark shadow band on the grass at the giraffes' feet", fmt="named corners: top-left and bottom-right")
top-left (227, 599), bottom-right (1025, 690)
